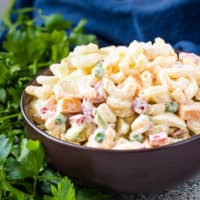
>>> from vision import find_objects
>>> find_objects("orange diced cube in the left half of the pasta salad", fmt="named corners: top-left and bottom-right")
top-left (57, 98), bottom-right (81, 114)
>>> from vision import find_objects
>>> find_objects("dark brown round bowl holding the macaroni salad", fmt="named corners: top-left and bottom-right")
top-left (21, 70), bottom-right (200, 192)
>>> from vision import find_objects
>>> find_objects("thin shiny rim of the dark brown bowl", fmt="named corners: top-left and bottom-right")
top-left (20, 89), bottom-right (200, 153)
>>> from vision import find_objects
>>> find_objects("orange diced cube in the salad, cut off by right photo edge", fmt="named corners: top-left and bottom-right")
top-left (179, 102), bottom-right (200, 120)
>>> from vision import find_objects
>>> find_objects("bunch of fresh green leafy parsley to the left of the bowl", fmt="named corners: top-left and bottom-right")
top-left (0, 1), bottom-right (108, 200)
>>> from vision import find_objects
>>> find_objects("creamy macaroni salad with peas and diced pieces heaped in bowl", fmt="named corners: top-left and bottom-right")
top-left (26, 38), bottom-right (200, 149)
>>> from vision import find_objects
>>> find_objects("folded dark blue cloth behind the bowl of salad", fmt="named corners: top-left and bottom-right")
top-left (13, 0), bottom-right (200, 54)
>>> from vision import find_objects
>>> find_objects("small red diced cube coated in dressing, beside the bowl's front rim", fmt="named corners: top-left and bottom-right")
top-left (149, 132), bottom-right (168, 146)
